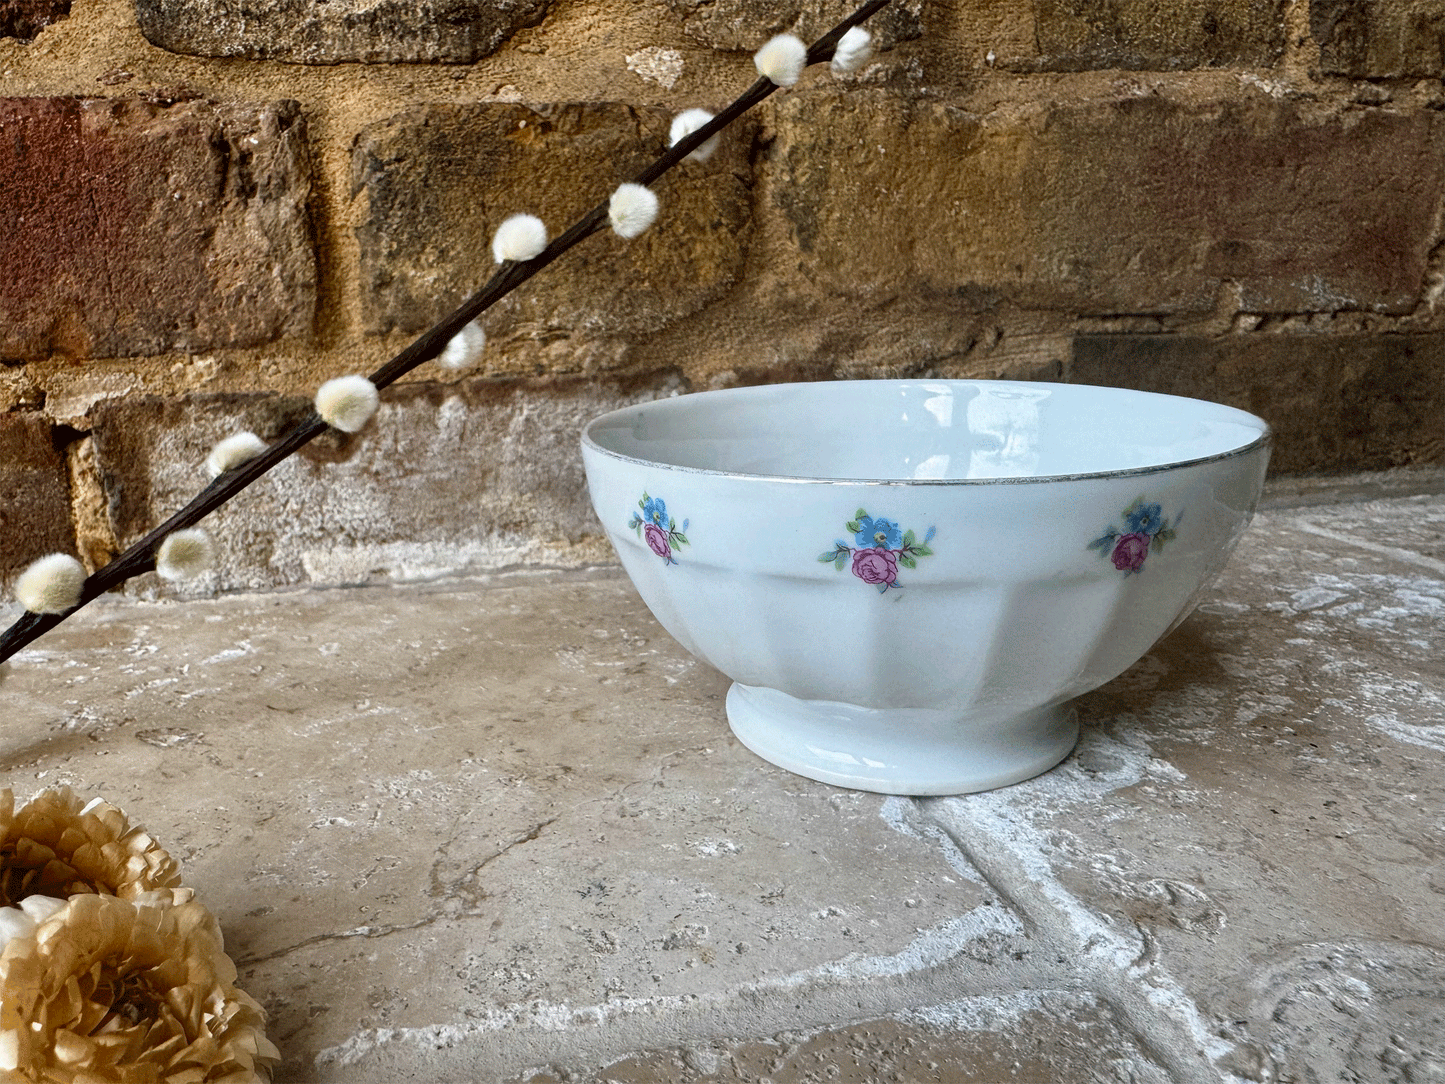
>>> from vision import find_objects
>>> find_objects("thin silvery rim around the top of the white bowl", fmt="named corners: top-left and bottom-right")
top-left (581, 379), bottom-right (1274, 486)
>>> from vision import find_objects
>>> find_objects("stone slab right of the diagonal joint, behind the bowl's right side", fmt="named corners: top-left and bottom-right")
top-left (932, 494), bottom-right (1445, 1083)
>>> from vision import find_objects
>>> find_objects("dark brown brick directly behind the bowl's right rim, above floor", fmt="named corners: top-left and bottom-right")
top-left (1068, 332), bottom-right (1445, 474)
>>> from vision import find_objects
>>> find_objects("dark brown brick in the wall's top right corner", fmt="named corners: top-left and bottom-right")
top-left (1309, 0), bottom-right (1445, 79)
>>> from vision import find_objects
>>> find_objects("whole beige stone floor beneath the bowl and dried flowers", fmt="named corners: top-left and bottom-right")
top-left (0, 473), bottom-right (1445, 1084)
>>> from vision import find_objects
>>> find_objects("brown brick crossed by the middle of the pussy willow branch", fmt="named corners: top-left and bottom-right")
top-left (353, 103), bottom-right (751, 348)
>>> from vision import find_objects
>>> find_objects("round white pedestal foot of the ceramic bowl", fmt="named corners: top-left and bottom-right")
top-left (727, 682), bottom-right (1079, 795)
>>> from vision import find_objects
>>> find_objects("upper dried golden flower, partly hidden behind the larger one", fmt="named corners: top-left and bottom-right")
top-left (0, 786), bottom-right (188, 906)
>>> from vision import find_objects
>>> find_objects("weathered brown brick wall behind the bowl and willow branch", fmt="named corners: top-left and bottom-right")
top-left (0, 0), bottom-right (1445, 590)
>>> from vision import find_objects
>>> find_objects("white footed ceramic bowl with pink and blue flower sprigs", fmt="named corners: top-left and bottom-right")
top-left (582, 380), bottom-right (1269, 795)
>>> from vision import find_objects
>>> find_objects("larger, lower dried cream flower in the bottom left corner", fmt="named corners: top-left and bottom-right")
top-left (0, 896), bottom-right (280, 1084)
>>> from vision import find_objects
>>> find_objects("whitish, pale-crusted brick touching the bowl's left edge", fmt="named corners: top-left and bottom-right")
top-left (91, 379), bottom-right (673, 590)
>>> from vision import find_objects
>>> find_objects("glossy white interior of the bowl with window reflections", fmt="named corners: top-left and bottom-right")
top-left (584, 380), bottom-right (1269, 481)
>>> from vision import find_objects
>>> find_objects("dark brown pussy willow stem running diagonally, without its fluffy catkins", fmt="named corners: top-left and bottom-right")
top-left (0, 0), bottom-right (892, 662)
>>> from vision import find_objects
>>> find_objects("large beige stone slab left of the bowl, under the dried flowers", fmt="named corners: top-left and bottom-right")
top-left (0, 574), bottom-right (994, 1083)
